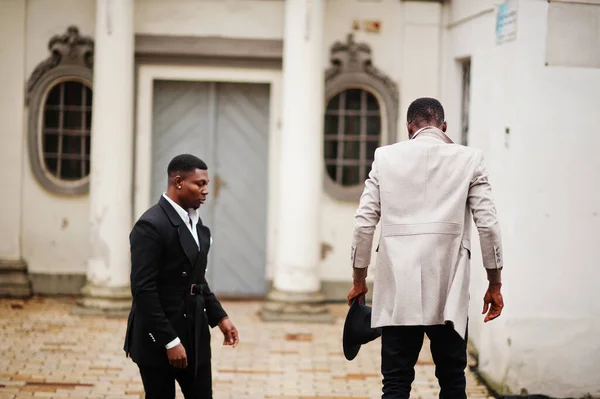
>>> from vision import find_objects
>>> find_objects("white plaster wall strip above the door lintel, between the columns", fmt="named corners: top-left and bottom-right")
top-left (135, 0), bottom-right (284, 39)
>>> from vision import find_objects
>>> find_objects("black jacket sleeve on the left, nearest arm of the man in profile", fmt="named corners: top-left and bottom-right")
top-left (129, 220), bottom-right (177, 347)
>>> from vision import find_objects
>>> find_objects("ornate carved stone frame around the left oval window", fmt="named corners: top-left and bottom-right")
top-left (25, 26), bottom-right (94, 195)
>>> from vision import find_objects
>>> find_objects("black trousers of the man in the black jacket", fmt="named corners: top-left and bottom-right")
top-left (138, 362), bottom-right (212, 399)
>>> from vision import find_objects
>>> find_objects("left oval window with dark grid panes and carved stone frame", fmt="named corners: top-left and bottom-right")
top-left (27, 27), bottom-right (93, 195)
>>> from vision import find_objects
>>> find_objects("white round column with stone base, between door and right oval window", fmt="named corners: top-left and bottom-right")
top-left (262, 0), bottom-right (332, 321)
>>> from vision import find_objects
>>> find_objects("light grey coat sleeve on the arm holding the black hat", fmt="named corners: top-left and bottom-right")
top-left (350, 149), bottom-right (381, 281)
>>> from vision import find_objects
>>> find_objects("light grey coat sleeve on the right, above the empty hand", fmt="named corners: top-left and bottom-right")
top-left (468, 152), bottom-right (503, 269)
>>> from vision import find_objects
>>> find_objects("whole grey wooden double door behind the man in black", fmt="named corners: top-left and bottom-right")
top-left (152, 81), bottom-right (269, 297)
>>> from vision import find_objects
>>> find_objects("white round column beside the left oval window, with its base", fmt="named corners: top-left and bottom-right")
top-left (80, 0), bottom-right (134, 310)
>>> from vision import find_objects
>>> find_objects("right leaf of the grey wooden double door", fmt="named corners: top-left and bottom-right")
top-left (210, 83), bottom-right (269, 295)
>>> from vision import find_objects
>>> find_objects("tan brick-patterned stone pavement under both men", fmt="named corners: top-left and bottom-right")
top-left (0, 297), bottom-right (490, 399)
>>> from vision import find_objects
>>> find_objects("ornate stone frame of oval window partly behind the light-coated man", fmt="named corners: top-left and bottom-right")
top-left (322, 34), bottom-right (399, 202)
